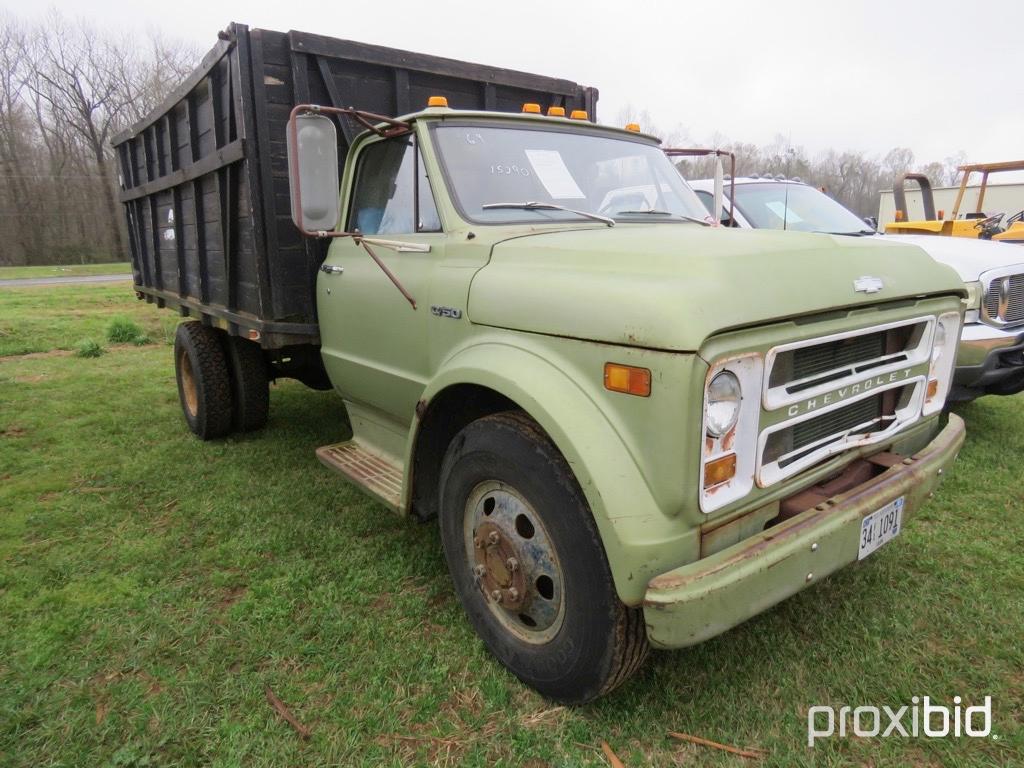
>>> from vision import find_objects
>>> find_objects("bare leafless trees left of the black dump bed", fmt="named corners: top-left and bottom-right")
top-left (0, 12), bottom-right (199, 265)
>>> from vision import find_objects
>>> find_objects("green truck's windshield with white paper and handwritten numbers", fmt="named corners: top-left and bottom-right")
top-left (433, 124), bottom-right (708, 224)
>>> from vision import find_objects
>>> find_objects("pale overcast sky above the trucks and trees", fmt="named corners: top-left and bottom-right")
top-left (9, 0), bottom-right (1024, 168)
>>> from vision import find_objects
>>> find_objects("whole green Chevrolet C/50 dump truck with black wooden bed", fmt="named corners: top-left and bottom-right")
top-left (117, 25), bottom-right (964, 702)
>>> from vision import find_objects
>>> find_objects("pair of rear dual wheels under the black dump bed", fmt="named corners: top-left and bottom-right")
top-left (174, 321), bottom-right (269, 440)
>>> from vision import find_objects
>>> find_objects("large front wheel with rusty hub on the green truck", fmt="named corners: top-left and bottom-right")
top-left (440, 412), bottom-right (648, 703)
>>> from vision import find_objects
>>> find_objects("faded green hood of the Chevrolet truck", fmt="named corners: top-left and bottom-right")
top-left (468, 223), bottom-right (964, 351)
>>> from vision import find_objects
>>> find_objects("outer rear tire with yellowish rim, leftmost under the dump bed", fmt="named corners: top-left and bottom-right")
top-left (174, 321), bottom-right (231, 440)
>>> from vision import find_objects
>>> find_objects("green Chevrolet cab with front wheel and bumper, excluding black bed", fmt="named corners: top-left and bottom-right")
top-left (292, 106), bottom-right (965, 700)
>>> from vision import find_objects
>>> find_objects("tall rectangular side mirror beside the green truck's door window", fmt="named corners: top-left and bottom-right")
top-left (288, 114), bottom-right (341, 232)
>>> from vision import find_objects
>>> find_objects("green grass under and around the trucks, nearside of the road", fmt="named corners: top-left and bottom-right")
top-left (0, 286), bottom-right (1024, 768)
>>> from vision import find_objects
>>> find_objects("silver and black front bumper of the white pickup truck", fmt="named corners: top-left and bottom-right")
top-left (950, 323), bottom-right (1024, 400)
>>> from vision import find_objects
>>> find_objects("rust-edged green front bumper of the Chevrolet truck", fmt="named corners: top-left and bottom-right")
top-left (643, 414), bottom-right (965, 648)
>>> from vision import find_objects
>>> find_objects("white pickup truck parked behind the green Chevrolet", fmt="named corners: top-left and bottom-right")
top-left (689, 176), bottom-right (1024, 402)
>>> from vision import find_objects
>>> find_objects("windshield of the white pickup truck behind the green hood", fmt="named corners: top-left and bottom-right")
top-left (735, 181), bottom-right (874, 234)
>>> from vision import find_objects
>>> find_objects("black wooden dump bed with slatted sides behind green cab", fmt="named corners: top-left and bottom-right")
top-left (114, 24), bottom-right (597, 349)
